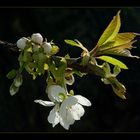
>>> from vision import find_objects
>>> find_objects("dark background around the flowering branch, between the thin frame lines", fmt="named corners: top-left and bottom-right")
top-left (0, 7), bottom-right (140, 132)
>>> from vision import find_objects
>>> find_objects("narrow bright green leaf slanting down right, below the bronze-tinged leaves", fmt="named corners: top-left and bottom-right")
top-left (97, 56), bottom-right (128, 69)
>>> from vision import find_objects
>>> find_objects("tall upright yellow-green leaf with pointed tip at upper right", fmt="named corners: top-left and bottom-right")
top-left (97, 11), bottom-right (121, 46)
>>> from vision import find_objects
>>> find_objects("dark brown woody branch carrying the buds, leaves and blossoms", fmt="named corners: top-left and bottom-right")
top-left (0, 40), bottom-right (104, 77)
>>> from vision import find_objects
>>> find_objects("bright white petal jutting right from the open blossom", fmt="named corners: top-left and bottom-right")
top-left (73, 95), bottom-right (91, 106)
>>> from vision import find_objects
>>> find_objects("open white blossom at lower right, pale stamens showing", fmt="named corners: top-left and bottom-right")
top-left (59, 95), bottom-right (91, 129)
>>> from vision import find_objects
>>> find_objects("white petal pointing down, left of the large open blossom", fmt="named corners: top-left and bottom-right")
top-left (48, 105), bottom-right (60, 127)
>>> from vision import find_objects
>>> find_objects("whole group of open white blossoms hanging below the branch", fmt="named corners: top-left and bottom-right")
top-left (35, 85), bottom-right (91, 130)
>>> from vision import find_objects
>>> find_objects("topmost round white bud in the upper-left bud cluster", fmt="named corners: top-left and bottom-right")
top-left (31, 33), bottom-right (43, 45)
